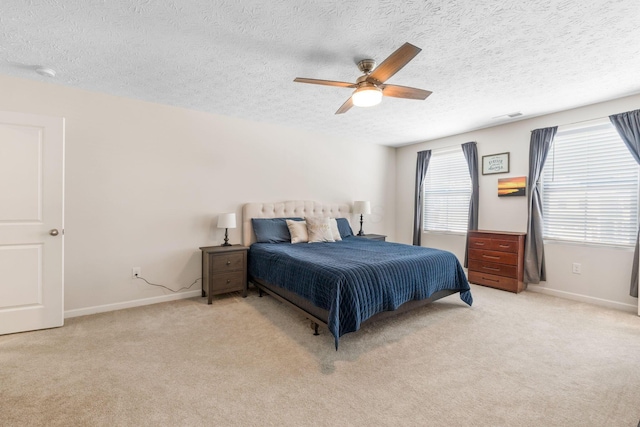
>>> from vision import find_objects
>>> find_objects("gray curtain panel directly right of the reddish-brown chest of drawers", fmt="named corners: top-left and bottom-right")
top-left (524, 126), bottom-right (558, 283)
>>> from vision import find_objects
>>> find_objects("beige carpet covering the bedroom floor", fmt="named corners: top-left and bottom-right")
top-left (0, 286), bottom-right (640, 427)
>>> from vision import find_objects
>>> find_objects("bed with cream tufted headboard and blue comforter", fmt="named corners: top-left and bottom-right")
top-left (242, 201), bottom-right (473, 350)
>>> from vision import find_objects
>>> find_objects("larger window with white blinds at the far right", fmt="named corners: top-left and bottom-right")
top-left (541, 120), bottom-right (638, 246)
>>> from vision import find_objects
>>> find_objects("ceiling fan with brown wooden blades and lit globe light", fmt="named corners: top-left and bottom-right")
top-left (293, 43), bottom-right (431, 114)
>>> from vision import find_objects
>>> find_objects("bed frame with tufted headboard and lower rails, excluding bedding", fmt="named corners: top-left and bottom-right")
top-left (242, 200), bottom-right (458, 335)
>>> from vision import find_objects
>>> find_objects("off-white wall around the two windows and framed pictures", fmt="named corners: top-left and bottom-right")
top-left (396, 95), bottom-right (640, 311)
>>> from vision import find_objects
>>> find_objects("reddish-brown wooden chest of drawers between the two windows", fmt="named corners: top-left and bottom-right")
top-left (468, 230), bottom-right (526, 293)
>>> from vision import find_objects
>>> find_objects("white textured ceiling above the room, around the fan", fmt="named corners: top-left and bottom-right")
top-left (0, 0), bottom-right (640, 146)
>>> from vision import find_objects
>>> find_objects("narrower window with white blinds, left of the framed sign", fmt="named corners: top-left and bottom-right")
top-left (423, 147), bottom-right (471, 233)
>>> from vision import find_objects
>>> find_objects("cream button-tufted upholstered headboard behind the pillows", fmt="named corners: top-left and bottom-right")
top-left (242, 200), bottom-right (351, 246)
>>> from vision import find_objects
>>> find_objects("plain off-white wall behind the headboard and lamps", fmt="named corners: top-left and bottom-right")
top-left (0, 76), bottom-right (395, 315)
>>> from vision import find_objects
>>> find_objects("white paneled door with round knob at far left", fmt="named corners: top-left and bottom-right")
top-left (0, 112), bottom-right (64, 334)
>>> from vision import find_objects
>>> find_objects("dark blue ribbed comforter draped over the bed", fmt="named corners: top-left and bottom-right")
top-left (248, 237), bottom-right (473, 349)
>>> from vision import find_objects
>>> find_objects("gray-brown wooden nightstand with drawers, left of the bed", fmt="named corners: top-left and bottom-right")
top-left (200, 245), bottom-right (249, 304)
